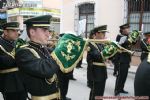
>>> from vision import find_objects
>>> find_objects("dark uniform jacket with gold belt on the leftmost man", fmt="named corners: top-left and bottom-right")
top-left (0, 37), bottom-right (24, 92)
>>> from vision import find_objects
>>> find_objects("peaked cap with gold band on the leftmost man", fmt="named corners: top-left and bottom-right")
top-left (2, 22), bottom-right (19, 30)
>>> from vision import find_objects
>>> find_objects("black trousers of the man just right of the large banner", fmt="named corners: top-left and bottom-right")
top-left (89, 80), bottom-right (106, 100)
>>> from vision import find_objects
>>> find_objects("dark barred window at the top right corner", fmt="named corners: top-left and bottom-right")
top-left (125, 0), bottom-right (150, 49)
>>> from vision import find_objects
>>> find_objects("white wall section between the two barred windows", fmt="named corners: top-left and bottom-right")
top-left (95, 0), bottom-right (124, 39)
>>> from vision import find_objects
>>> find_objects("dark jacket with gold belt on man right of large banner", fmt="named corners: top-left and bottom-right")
top-left (87, 43), bottom-right (107, 81)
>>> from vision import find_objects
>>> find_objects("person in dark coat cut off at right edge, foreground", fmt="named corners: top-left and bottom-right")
top-left (134, 53), bottom-right (150, 96)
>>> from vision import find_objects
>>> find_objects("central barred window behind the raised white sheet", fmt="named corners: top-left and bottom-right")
top-left (78, 3), bottom-right (94, 38)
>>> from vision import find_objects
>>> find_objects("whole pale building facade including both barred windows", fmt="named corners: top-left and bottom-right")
top-left (61, 0), bottom-right (150, 40)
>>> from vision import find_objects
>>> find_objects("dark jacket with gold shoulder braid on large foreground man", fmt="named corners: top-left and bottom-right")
top-left (16, 42), bottom-right (59, 96)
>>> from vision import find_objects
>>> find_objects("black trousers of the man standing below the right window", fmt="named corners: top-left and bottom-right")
top-left (115, 63), bottom-right (130, 94)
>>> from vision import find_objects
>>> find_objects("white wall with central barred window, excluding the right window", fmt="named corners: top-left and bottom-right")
top-left (61, 0), bottom-right (124, 39)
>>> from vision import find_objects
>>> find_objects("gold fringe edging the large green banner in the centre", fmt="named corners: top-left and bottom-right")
top-left (51, 41), bottom-right (88, 73)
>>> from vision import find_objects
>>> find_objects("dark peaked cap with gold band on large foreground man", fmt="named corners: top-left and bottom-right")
top-left (24, 15), bottom-right (52, 27)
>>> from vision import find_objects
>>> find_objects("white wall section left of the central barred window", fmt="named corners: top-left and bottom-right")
top-left (60, 0), bottom-right (95, 32)
